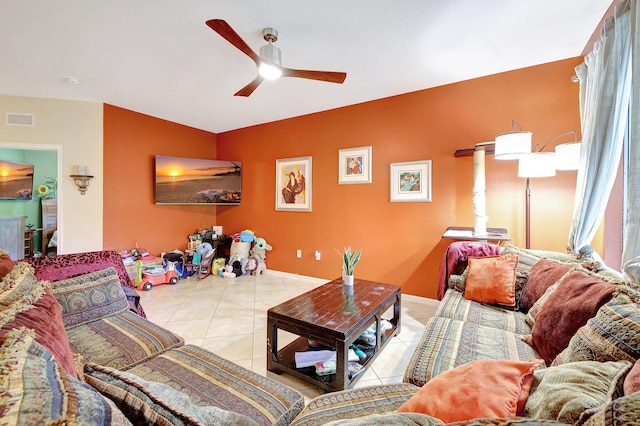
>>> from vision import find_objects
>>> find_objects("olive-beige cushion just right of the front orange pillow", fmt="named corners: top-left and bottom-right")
top-left (523, 361), bottom-right (631, 424)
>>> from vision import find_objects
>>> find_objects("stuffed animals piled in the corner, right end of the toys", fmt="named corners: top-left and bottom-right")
top-left (218, 229), bottom-right (272, 278)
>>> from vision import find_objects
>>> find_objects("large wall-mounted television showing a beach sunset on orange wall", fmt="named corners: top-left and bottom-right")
top-left (155, 155), bottom-right (242, 205)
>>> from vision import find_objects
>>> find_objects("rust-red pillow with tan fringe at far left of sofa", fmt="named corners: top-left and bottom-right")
top-left (0, 262), bottom-right (77, 377)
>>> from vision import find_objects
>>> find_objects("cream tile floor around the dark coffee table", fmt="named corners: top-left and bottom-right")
top-left (139, 271), bottom-right (438, 400)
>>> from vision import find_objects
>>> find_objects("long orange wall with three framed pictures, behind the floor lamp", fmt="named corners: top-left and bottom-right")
top-left (218, 58), bottom-right (588, 298)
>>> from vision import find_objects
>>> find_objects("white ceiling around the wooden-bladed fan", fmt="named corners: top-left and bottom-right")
top-left (0, 0), bottom-right (612, 133)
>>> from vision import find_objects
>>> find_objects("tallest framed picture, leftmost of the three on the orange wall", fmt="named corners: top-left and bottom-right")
top-left (276, 157), bottom-right (312, 212)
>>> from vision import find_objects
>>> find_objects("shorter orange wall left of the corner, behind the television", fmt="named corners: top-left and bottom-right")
top-left (103, 105), bottom-right (216, 255)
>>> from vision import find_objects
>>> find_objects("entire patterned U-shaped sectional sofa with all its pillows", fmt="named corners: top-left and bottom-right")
top-left (0, 246), bottom-right (640, 426)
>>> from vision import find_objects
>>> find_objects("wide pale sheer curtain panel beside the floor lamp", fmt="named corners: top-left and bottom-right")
top-left (567, 0), bottom-right (637, 255)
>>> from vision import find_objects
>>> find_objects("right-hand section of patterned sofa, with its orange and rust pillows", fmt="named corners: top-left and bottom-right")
top-left (292, 243), bottom-right (640, 426)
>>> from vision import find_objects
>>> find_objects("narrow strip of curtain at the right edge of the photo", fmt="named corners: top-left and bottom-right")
top-left (622, 0), bottom-right (640, 283)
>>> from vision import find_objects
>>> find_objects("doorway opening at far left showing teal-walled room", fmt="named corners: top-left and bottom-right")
top-left (0, 143), bottom-right (60, 260)
